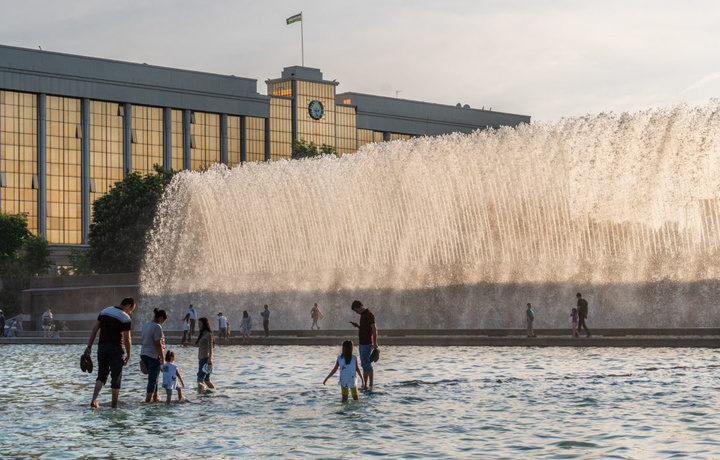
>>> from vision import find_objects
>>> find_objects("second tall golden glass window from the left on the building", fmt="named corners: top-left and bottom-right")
top-left (46, 96), bottom-right (82, 244)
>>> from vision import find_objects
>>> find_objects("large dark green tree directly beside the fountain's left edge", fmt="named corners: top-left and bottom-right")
top-left (88, 172), bottom-right (163, 273)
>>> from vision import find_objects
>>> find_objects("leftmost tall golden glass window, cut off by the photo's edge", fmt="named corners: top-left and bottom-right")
top-left (0, 91), bottom-right (38, 233)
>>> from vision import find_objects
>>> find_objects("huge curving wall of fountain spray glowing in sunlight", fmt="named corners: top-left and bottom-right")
top-left (141, 100), bottom-right (720, 329)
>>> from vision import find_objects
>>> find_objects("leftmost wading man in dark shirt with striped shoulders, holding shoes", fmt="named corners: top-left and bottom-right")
top-left (85, 297), bottom-right (135, 408)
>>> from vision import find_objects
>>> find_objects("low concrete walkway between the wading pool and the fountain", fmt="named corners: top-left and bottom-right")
top-left (0, 328), bottom-right (720, 348)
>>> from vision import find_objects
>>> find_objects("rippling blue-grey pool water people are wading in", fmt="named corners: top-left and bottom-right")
top-left (0, 345), bottom-right (720, 458)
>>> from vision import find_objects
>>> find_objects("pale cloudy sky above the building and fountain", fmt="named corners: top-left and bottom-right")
top-left (0, 0), bottom-right (720, 122)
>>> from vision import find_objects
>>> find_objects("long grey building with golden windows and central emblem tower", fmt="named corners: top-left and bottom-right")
top-left (0, 46), bottom-right (530, 264)
